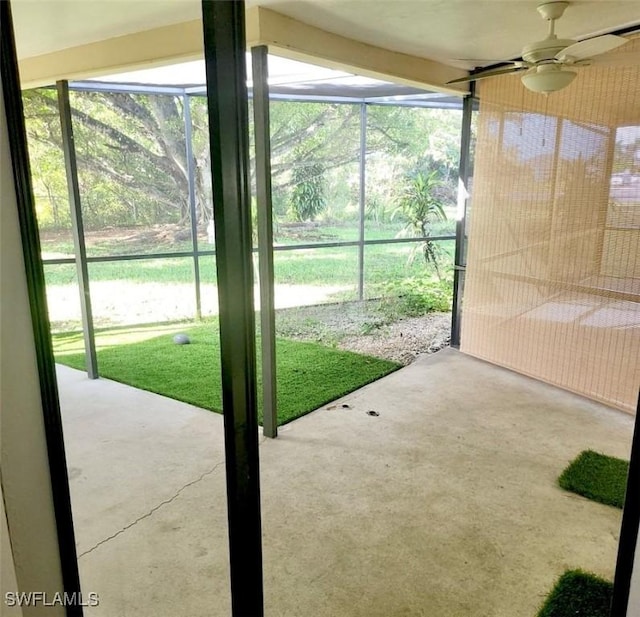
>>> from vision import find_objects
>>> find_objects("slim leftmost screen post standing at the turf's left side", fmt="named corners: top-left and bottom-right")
top-left (57, 81), bottom-right (98, 379)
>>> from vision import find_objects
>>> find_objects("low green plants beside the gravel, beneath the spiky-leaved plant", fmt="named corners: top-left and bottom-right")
top-left (381, 273), bottom-right (453, 317)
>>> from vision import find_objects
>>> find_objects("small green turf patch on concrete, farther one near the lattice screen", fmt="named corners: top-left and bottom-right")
top-left (558, 450), bottom-right (629, 508)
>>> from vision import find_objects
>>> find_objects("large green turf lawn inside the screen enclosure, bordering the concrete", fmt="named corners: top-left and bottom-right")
top-left (53, 320), bottom-right (400, 424)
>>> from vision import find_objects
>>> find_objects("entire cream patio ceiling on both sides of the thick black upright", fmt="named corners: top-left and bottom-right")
top-left (12, 0), bottom-right (640, 67)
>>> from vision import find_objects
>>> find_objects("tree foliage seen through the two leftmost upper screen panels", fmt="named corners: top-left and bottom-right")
top-left (23, 89), bottom-right (189, 229)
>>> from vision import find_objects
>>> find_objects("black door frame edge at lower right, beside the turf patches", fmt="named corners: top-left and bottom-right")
top-left (611, 396), bottom-right (640, 617)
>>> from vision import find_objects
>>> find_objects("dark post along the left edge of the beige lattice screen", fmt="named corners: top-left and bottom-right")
top-left (451, 91), bottom-right (475, 347)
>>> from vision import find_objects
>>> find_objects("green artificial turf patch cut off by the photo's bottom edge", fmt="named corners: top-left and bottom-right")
top-left (538, 570), bottom-right (613, 617)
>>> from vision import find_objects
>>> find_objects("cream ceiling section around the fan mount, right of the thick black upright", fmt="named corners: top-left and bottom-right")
top-left (252, 0), bottom-right (640, 64)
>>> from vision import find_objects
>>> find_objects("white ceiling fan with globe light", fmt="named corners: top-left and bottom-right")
top-left (447, 2), bottom-right (640, 94)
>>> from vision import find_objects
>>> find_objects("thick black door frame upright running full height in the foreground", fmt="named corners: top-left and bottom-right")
top-left (202, 0), bottom-right (264, 617)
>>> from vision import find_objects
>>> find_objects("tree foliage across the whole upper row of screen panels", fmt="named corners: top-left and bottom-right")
top-left (24, 89), bottom-right (461, 237)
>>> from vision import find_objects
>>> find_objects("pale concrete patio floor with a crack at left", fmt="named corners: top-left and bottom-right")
top-left (58, 350), bottom-right (633, 617)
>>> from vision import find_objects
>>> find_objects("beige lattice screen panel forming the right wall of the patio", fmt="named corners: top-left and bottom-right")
top-left (461, 38), bottom-right (640, 412)
